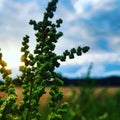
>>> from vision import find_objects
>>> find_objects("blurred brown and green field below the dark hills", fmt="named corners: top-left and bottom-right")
top-left (0, 87), bottom-right (120, 120)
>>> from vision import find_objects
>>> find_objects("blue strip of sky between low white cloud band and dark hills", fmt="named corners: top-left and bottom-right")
top-left (57, 62), bottom-right (120, 78)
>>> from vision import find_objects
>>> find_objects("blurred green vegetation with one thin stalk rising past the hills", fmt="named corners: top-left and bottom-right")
top-left (64, 64), bottom-right (120, 120)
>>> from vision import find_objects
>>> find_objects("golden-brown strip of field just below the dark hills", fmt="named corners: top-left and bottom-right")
top-left (0, 87), bottom-right (120, 104)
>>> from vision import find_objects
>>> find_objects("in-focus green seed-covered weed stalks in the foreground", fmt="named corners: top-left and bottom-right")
top-left (0, 0), bottom-right (89, 120)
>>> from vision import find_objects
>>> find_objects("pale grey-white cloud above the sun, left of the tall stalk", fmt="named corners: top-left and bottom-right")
top-left (0, 0), bottom-right (42, 50)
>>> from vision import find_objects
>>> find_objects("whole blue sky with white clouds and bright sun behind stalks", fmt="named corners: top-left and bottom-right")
top-left (0, 0), bottom-right (120, 78)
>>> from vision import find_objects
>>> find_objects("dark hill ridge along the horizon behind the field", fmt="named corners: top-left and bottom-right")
top-left (0, 76), bottom-right (120, 87)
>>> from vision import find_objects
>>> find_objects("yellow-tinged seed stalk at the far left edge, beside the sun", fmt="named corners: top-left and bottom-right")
top-left (0, 51), bottom-right (18, 120)
